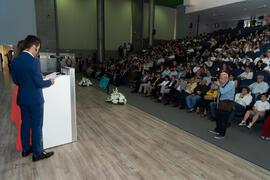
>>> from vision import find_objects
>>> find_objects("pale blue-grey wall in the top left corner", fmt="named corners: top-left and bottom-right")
top-left (0, 0), bottom-right (36, 45)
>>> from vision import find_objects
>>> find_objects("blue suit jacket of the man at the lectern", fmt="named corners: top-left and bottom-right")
top-left (11, 52), bottom-right (52, 105)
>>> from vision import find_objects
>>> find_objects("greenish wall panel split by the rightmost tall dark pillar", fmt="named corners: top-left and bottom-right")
top-left (143, 3), bottom-right (176, 40)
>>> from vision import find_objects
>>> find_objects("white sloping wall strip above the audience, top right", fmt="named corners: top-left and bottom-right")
top-left (184, 0), bottom-right (246, 13)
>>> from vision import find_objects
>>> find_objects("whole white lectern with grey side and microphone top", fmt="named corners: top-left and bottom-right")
top-left (43, 67), bottom-right (77, 149)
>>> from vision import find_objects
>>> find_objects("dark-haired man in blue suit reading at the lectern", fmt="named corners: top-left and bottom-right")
top-left (11, 35), bottom-right (54, 161)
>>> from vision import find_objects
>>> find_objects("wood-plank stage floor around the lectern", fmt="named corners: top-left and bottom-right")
top-left (0, 71), bottom-right (270, 180)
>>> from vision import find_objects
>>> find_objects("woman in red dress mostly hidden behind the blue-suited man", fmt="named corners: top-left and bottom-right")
top-left (10, 40), bottom-right (30, 151)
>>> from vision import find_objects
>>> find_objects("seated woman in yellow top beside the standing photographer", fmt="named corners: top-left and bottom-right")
top-left (196, 82), bottom-right (218, 117)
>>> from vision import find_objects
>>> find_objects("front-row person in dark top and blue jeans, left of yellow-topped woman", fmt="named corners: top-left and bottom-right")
top-left (186, 79), bottom-right (209, 112)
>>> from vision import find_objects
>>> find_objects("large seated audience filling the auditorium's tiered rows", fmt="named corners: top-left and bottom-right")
top-left (85, 23), bottom-right (270, 139)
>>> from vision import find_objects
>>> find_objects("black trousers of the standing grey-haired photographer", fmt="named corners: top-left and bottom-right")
top-left (215, 110), bottom-right (230, 136)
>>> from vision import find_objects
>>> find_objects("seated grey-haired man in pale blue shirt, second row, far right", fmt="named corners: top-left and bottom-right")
top-left (249, 75), bottom-right (269, 97)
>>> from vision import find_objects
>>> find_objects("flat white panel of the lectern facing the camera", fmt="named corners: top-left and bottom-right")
top-left (43, 75), bottom-right (72, 149)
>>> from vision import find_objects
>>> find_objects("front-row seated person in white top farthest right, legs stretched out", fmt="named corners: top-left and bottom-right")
top-left (239, 93), bottom-right (270, 128)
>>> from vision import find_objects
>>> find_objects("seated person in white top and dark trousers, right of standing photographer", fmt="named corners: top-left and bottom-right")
top-left (228, 87), bottom-right (252, 123)
